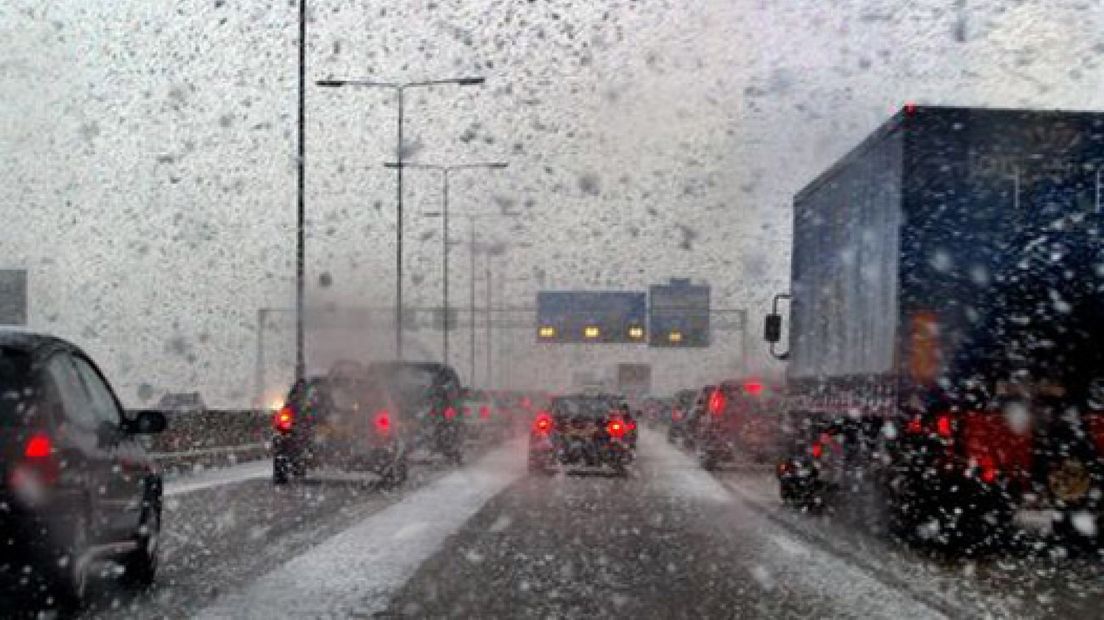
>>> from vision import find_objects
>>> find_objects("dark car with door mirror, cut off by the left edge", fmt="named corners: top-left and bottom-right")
top-left (0, 330), bottom-right (164, 607)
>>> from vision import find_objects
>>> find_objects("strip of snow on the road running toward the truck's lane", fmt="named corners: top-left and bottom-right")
top-left (640, 430), bottom-right (944, 619)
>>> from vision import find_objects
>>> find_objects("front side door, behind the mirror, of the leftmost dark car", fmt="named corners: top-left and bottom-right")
top-left (73, 355), bottom-right (147, 538)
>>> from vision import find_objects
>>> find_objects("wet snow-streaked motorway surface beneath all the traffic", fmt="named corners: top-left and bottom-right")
top-left (80, 431), bottom-right (1098, 618)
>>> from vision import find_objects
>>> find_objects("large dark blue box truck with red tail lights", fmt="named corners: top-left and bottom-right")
top-left (766, 105), bottom-right (1104, 545)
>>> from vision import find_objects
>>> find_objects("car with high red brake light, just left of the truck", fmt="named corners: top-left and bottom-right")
top-left (694, 378), bottom-right (784, 470)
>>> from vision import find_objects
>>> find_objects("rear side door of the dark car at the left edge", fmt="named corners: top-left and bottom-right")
top-left (43, 351), bottom-right (114, 538)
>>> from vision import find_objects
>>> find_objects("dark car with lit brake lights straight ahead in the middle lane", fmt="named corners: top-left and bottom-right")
top-left (529, 395), bottom-right (636, 475)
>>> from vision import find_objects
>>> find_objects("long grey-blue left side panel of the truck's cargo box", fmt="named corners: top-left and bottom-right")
top-left (789, 121), bottom-right (903, 380)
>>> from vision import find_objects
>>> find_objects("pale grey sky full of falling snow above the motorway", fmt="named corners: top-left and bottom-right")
top-left (0, 0), bottom-right (1104, 405)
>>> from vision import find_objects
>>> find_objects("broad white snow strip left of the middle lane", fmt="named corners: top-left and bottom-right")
top-left (198, 440), bottom-right (526, 620)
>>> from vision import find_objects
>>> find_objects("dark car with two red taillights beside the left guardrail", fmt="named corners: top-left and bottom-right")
top-left (272, 366), bottom-right (415, 487)
